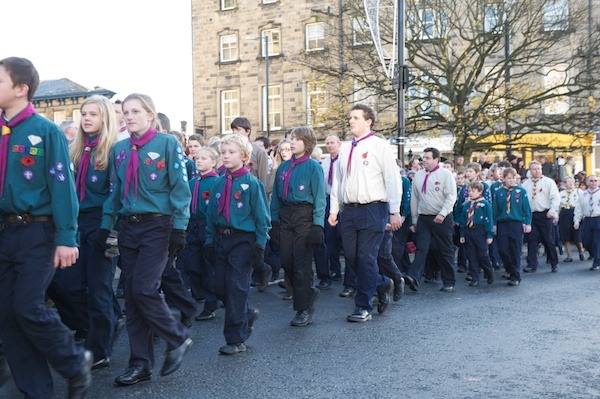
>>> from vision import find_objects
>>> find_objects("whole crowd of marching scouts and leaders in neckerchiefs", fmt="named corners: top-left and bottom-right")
top-left (0, 57), bottom-right (600, 398)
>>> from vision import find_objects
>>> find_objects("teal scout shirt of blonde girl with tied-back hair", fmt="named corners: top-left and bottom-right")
top-left (102, 133), bottom-right (192, 230)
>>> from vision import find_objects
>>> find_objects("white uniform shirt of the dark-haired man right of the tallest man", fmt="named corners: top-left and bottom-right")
top-left (410, 166), bottom-right (457, 225)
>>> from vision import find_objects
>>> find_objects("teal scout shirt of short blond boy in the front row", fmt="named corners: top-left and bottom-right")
top-left (206, 173), bottom-right (271, 248)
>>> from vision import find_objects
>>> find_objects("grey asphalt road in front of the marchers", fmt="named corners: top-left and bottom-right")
top-left (0, 259), bottom-right (600, 399)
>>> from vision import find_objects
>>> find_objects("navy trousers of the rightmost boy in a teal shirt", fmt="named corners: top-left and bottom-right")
top-left (496, 220), bottom-right (523, 281)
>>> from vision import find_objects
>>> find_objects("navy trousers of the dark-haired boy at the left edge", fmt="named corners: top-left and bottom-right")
top-left (0, 221), bottom-right (84, 398)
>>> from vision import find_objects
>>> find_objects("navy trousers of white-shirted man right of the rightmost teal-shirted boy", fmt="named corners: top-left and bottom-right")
top-left (527, 211), bottom-right (558, 270)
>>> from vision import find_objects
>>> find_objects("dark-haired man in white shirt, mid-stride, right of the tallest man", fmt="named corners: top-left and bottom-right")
top-left (404, 147), bottom-right (457, 292)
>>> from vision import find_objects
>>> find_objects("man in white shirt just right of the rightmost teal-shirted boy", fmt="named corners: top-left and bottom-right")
top-left (523, 161), bottom-right (560, 273)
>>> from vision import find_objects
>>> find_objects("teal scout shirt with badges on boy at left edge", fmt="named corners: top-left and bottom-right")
top-left (0, 114), bottom-right (79, 247)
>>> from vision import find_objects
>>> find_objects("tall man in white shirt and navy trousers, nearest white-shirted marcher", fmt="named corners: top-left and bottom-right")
top-left (328, 104), bottom-right (402, 322)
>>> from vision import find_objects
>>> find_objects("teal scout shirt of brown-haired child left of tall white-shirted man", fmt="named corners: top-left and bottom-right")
top-left (271, 159), bottom-right (327, 227)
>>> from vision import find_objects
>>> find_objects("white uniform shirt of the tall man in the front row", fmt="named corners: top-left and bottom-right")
top-left (330, 136), bottom-right (402, 215)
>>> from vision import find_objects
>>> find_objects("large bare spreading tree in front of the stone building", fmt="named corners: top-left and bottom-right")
top-left (296, 0), bottom-right (600, 155)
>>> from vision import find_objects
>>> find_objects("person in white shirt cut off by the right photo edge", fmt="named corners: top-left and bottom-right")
top-left (573, 175), bottom-right (600, 270)
